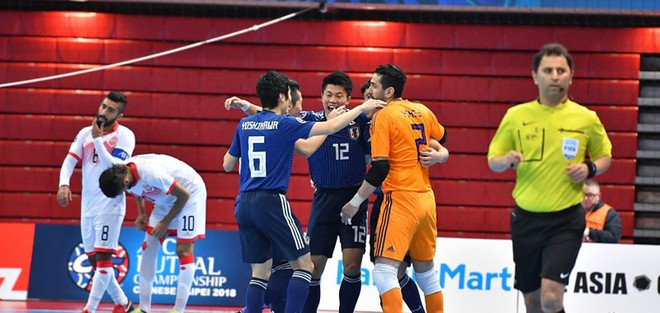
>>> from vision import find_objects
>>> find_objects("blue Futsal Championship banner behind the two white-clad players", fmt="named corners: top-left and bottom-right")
top-left (28, 225), bottom-right (250, 306)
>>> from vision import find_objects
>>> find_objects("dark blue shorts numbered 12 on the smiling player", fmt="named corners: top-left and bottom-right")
top-left (307, 187), bottom-right (369, 258)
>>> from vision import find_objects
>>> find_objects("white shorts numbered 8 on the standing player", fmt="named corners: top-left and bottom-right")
top-left (80, 214), bottom-right (124, 254)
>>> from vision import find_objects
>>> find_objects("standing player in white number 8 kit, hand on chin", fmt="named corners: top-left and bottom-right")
top-left (57, 91), bottom-right (135, 313)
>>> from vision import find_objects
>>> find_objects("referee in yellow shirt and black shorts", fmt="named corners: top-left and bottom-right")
top-left (488, 43), bottom-right (612, 312)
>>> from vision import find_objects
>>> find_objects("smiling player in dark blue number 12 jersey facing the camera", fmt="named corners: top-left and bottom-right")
top-left (298, 71), bottom-right (370, 313)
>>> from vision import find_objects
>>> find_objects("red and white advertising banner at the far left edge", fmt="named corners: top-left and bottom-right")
top-left (0, 223), bottom-right (34, 300)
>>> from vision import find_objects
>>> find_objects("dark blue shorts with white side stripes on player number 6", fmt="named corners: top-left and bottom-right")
top-left (236, 190), bottom-right (309, 264)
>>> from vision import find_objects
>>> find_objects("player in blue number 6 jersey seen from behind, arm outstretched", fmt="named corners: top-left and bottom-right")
top-left (223, 71), bottom-right (384, 313)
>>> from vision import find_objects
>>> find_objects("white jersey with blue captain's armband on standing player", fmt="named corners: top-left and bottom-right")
top-left (69, 123), bottom-right (135, 217)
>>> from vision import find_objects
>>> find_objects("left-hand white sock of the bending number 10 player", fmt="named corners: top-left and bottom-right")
top-left (139, 235), bottom-right (160, 312)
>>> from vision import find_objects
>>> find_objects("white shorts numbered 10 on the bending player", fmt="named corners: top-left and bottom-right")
top-left (149, 188), bottom-right (206, 242)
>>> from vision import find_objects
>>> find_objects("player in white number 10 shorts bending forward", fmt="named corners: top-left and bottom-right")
top-left (99, 154), bottom-right (206, 312)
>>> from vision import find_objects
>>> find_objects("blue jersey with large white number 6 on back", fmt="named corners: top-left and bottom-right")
top-left (229, 110), bottom-right (314, 193)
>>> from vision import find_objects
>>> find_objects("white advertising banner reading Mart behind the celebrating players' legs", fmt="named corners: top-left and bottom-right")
top-left (319, 238), bottom-right (525, 313)
